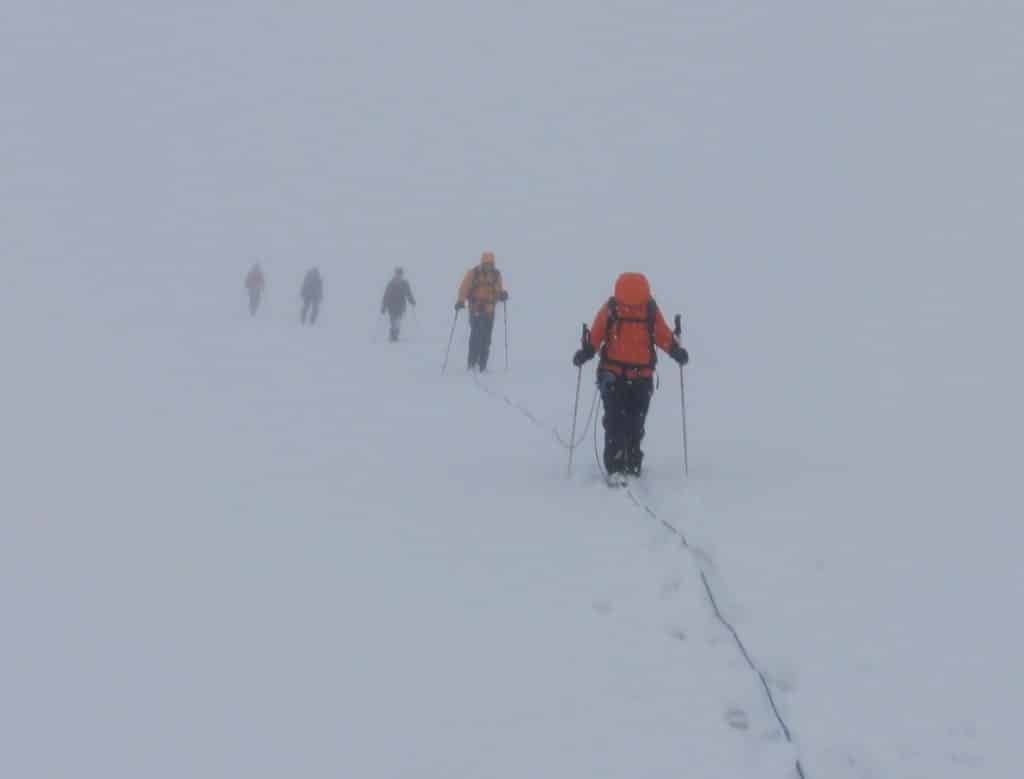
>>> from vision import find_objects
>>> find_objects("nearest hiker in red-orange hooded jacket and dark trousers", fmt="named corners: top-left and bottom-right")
top-left (572, 273), bottom-right (689, 483)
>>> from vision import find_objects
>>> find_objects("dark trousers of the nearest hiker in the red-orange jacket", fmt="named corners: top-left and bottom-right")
top-left (598, 371), bottom-right (654, 476)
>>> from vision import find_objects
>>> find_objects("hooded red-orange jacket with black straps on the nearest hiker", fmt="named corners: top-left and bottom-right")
top-left (590, 273), bottom-right (675, 378)
